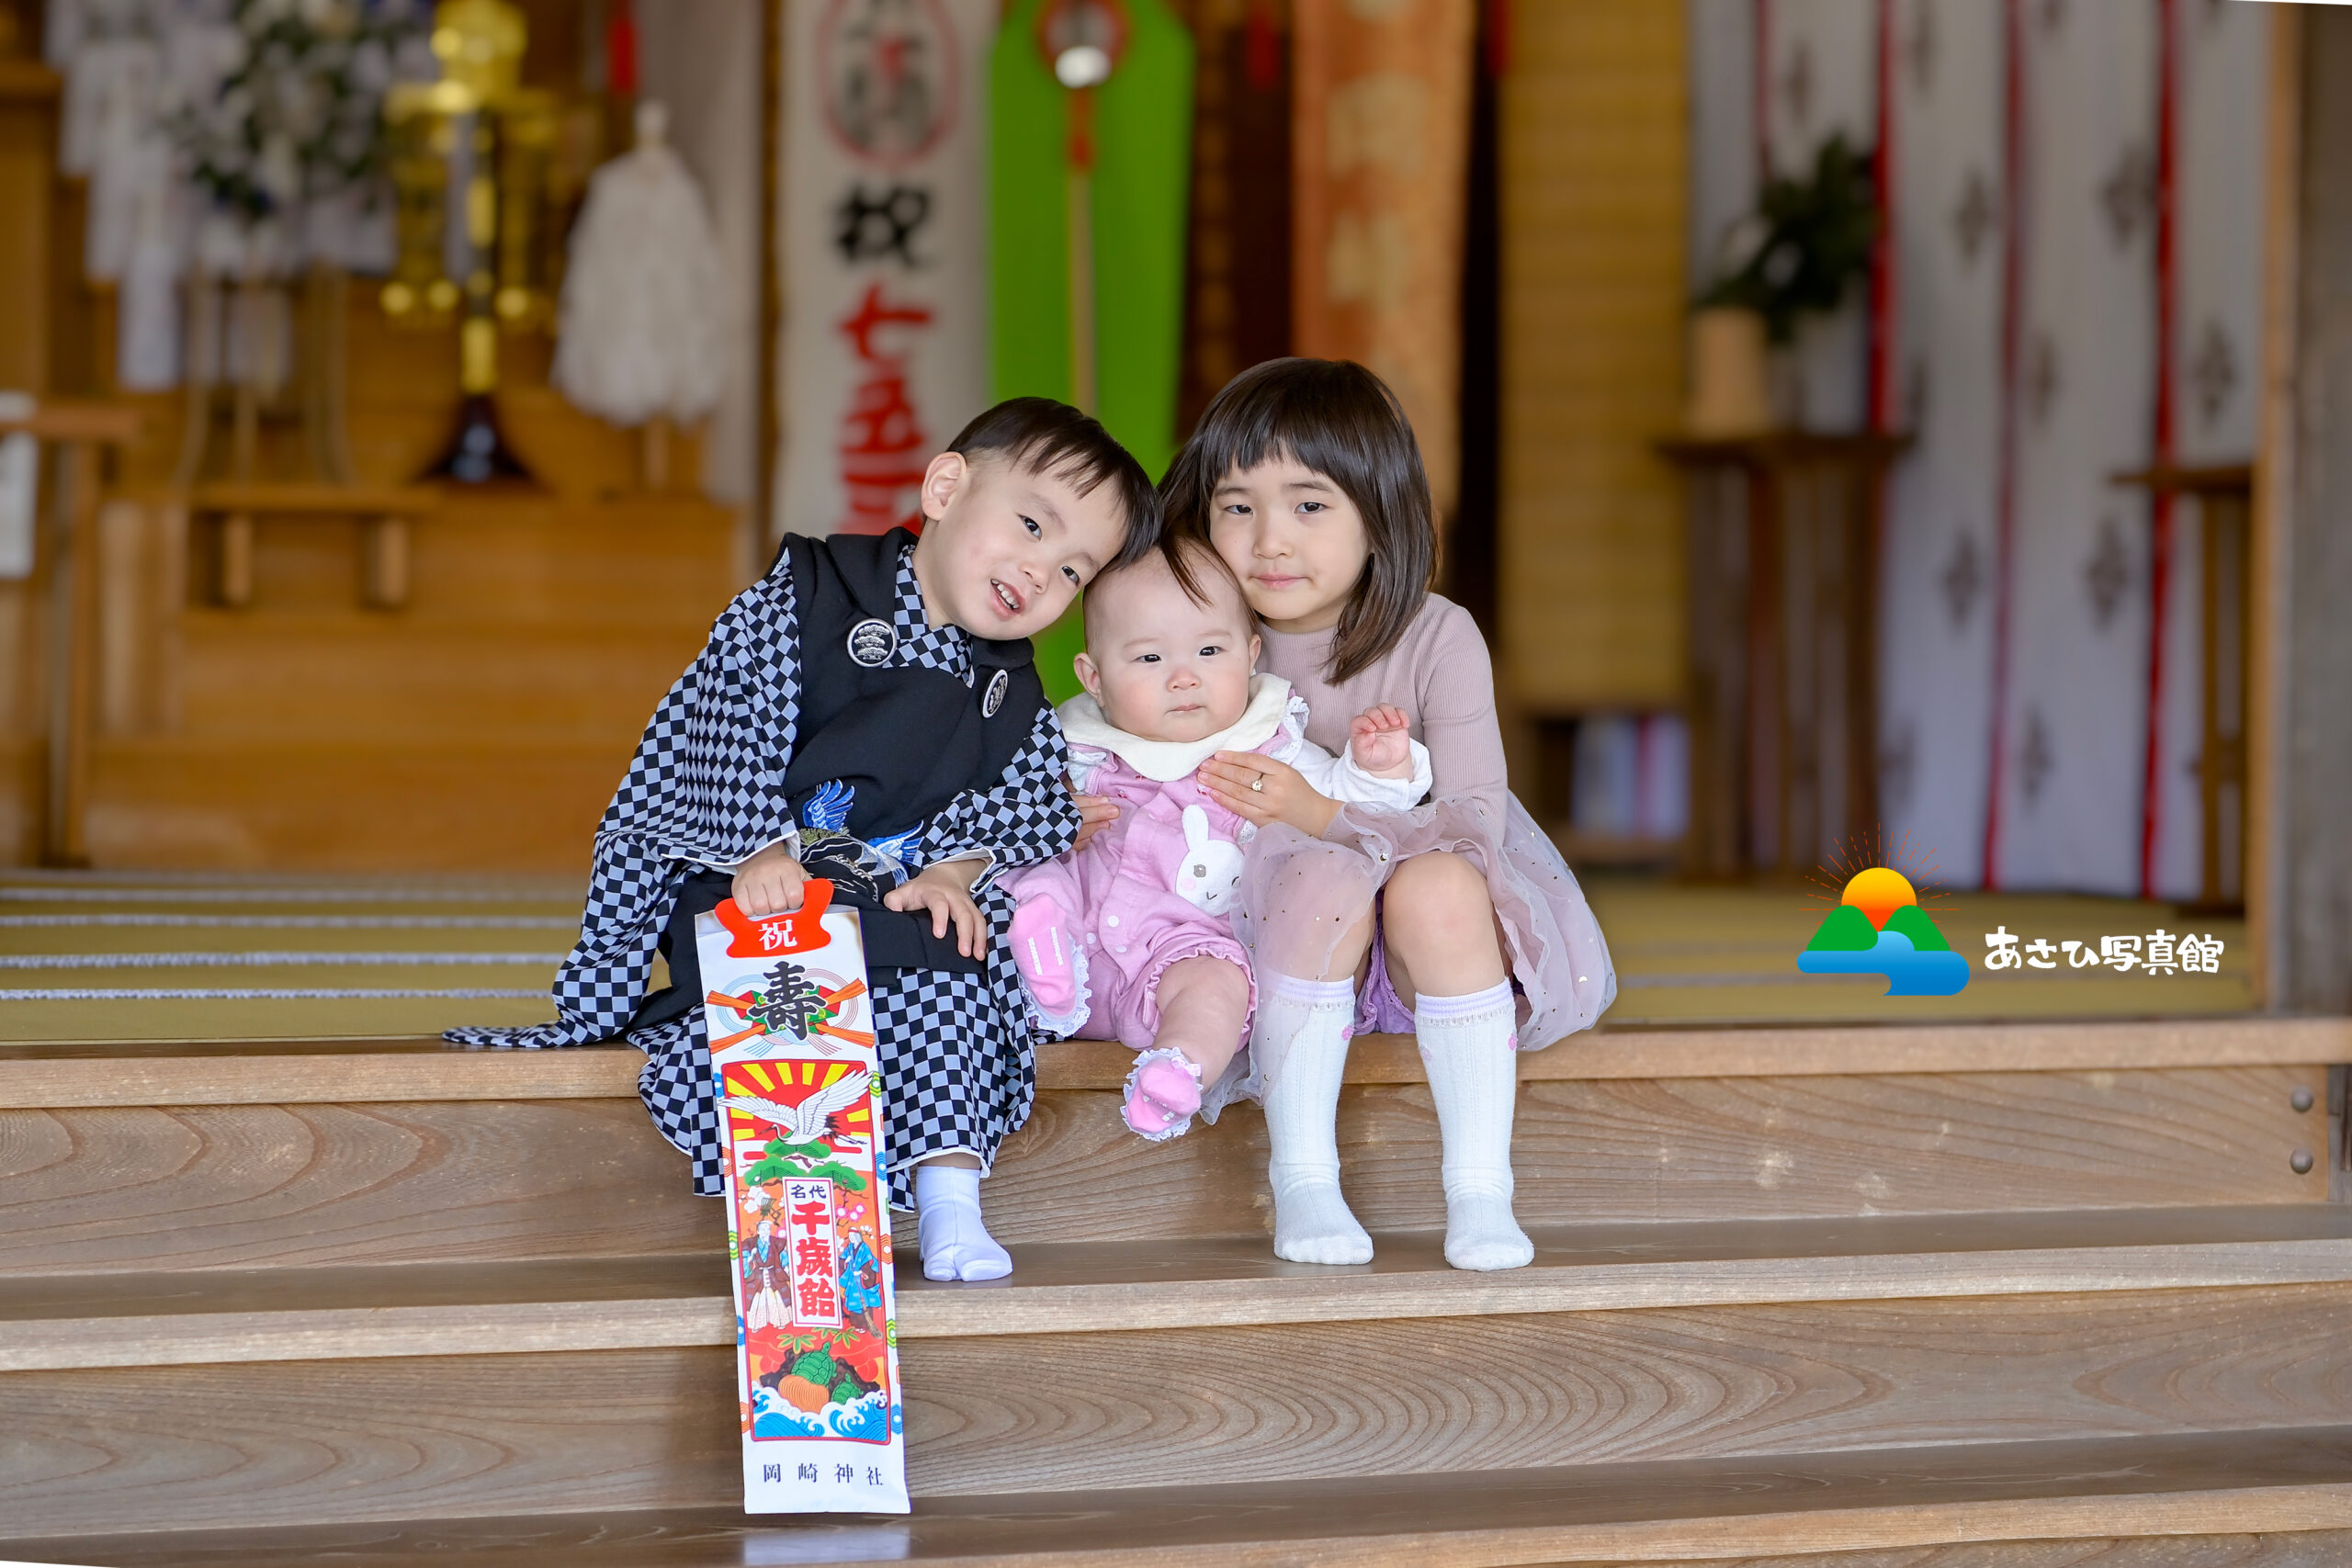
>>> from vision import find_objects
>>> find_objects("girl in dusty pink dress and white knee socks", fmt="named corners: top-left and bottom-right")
top-left (1159, 360), bottom-right (1616, 1269)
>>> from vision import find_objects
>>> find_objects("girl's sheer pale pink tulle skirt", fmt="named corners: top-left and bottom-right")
top-left (1204, 795), bottom-right (1616, 1114)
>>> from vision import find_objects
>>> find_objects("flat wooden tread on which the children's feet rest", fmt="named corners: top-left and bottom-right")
top-left (18, 1203), bottom-right (2352, 1373)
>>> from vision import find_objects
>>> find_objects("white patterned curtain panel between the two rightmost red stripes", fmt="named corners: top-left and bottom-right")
top-left (1987, 0), bottom-right (2159, 896)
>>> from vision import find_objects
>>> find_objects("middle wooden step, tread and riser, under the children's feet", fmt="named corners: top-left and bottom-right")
top-left (14, 1208), bottom-right (2352, 1533)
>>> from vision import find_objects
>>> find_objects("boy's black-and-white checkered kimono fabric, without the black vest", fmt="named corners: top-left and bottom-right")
top-left (449, 547), bottom-right (1077, 1208)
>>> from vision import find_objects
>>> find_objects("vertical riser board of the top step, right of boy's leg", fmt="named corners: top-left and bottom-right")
top-left (988, 1062), bottom-right (2328, 1241)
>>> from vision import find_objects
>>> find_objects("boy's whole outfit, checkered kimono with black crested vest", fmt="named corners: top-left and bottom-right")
top-left (449, 529), bottom-right (1077, 1206)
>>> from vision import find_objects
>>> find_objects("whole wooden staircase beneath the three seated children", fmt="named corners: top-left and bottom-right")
top-left (0, 1021), bottom-right (2352, 1568)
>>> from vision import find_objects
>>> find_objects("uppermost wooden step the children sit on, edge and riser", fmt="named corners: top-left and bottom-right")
top-left (0, 1025), bottom-right (2345, 1274)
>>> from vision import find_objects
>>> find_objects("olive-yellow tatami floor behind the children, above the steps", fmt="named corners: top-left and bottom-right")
top-left (0, 872), bottom-right (2251, 1042)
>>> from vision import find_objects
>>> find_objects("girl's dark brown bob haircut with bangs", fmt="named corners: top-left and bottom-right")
top-left (1159, 360), bottom-right (1437, 682)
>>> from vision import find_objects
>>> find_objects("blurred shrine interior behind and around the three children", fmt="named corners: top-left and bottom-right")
top-left (0, 0), bottom-right (2352, 1037)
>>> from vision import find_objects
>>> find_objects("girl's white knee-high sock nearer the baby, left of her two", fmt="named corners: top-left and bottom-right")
top-left (1251, 976), bottom-right (1371, 1262)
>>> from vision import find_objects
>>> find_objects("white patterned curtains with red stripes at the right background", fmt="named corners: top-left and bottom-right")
top-left (1691, 0), bottom-right (2267, 898)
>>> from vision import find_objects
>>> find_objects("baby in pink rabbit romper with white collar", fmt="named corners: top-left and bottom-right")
top-left (1004, 538), bottom-right (1430, 1143)
